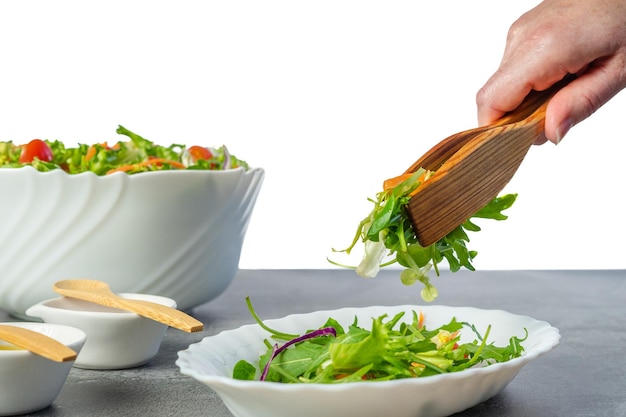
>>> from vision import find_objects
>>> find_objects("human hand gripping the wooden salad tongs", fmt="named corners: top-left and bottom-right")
top-left (476, 0), bottom-right (626, 144)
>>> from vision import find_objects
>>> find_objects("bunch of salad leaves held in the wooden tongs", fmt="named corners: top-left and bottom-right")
top-left (329, 168), bottom-right (517, 301)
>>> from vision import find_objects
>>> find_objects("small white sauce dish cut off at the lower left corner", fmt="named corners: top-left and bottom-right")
top-left (0, 322), bottom-right (85, 416)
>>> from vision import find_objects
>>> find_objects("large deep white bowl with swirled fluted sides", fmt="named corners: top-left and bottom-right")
top-left (0, 166), bottom-right (264, 318)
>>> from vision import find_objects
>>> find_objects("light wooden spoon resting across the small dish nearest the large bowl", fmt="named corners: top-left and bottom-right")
top-left (53, 279), bottom-right (204, 333)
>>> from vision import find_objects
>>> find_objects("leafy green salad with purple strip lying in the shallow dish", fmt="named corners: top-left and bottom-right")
top-left (233, 298), bottom-right (528, 384)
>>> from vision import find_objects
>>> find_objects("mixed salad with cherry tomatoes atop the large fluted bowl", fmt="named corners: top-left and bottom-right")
top-left (0, 126), bottom-right (249, 175)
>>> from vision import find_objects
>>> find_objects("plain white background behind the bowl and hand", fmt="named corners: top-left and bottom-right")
top-left (0, 0), bottom-right (626, 269)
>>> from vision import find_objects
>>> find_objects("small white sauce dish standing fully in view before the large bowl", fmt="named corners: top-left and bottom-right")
top-left (26, 293), bottom-right (176, 369)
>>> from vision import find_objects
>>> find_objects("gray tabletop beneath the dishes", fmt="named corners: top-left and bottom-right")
top-left (0, 269), bottom-right (626, 417)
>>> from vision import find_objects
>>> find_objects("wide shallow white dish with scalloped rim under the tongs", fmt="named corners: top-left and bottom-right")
top-left (176, 306), bottom-right (560, 417)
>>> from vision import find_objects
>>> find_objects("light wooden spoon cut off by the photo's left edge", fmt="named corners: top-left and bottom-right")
top-left (0, 324), bottom-right (78, 362)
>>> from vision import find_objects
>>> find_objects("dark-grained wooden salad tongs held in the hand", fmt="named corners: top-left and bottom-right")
top-left (405, 77), bottom-right (572, 246)
